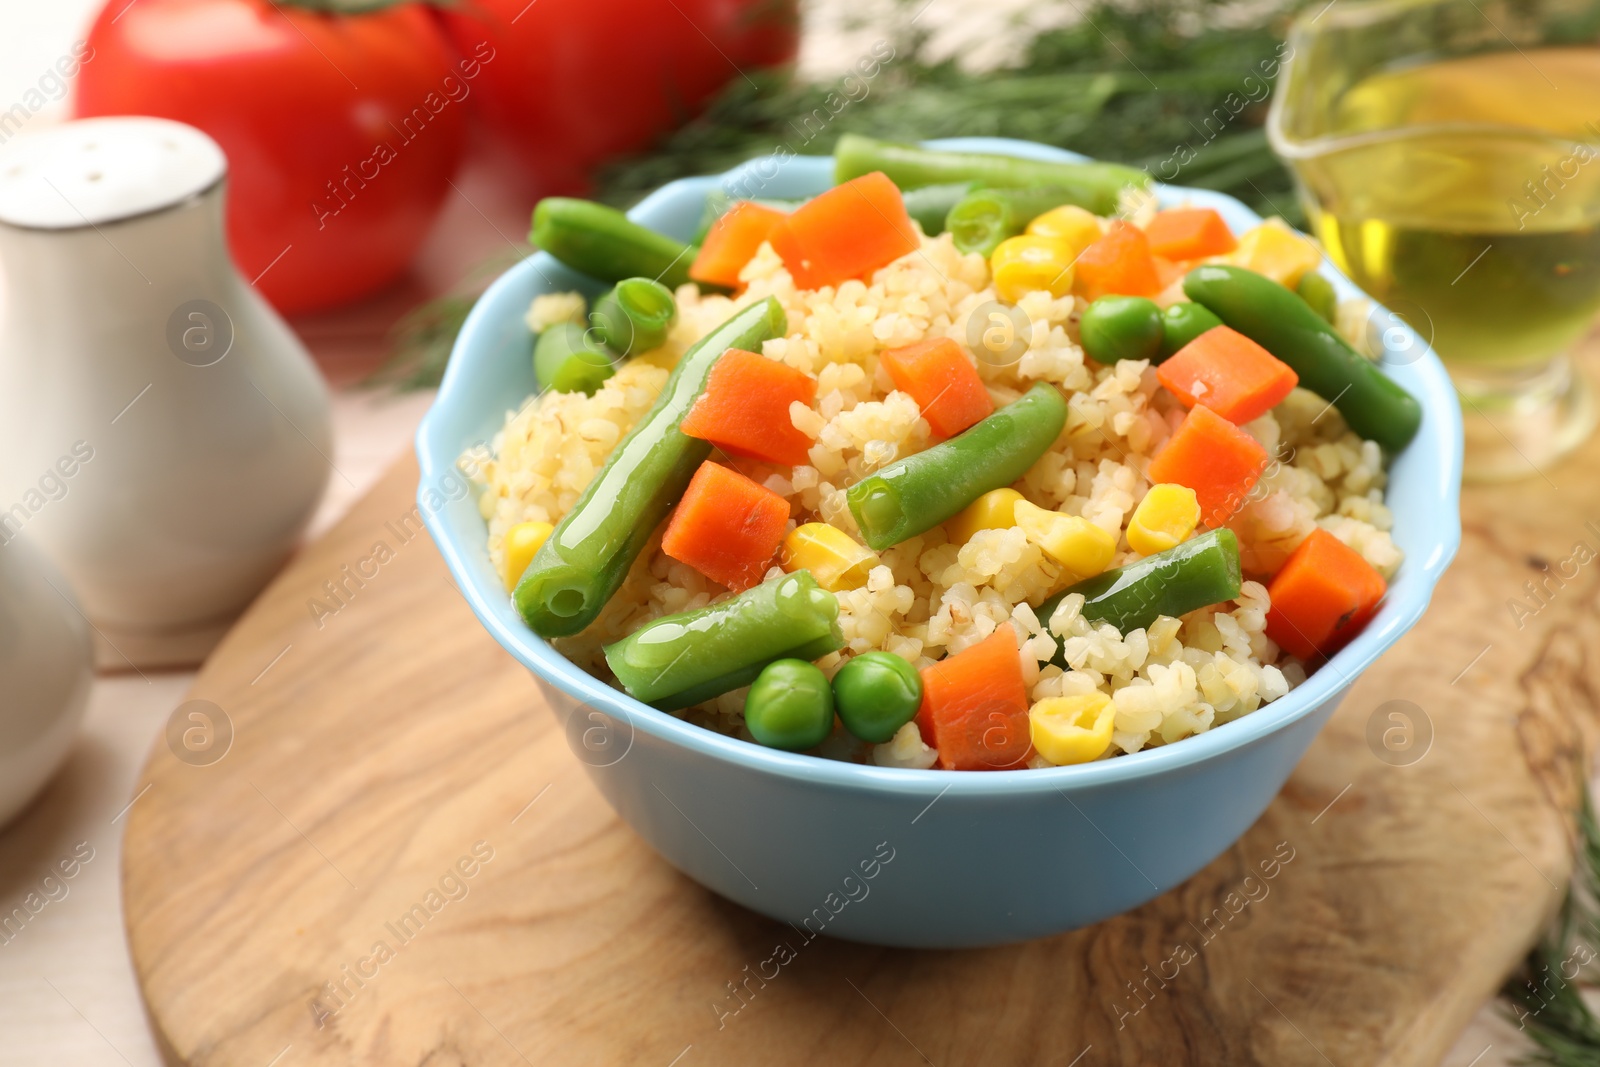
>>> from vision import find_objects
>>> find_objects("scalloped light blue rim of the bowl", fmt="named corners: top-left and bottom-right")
top-left (416, 138), bottom-right (1462, 797)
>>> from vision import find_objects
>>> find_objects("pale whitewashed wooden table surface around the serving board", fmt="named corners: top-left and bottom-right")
top-left (0, 0), bottom-right (1548, 1067)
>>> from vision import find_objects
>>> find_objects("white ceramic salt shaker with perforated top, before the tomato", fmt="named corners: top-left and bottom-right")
top-left (0, 117), bottom-right (331, 665)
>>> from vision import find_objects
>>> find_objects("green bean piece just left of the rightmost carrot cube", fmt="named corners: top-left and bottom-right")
top-left (1035, 530), bottom-right (1242, 655)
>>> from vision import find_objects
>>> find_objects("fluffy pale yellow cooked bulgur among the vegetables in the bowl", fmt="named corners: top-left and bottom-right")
top-left (464, 225), bottom-right (1400, 768)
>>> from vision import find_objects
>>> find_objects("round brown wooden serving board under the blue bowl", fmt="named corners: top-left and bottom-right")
top-left (123, 442), bottom-right (1600, 1067)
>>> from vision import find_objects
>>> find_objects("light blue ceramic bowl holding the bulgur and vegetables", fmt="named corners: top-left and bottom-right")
top-left (418, 138), bottom-right (1461, 947)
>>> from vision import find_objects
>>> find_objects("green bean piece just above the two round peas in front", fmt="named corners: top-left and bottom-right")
top-left (605, 571), bottom-right (845, 710)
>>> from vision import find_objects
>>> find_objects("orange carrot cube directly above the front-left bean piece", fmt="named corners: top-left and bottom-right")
top-left (661, 461), bottom-right (789, 592)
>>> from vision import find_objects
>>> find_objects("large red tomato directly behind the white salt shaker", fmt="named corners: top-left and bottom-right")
top-left (75, 0), bottom-right (467, 312)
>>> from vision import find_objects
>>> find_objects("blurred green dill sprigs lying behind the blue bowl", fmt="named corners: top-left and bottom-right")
top-left (376, 0), bottom-right (1302, 389)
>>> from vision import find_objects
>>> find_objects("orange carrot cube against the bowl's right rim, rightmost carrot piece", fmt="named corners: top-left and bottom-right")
top-left (1267, 526), bottom-right (1389, 659)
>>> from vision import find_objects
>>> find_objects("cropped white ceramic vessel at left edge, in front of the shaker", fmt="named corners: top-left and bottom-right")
top-left (0, 536), bottom-right (93, 825)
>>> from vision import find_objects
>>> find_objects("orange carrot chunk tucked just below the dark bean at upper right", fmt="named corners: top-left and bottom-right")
top-left (1155, 326), bottom-right (1299, 424)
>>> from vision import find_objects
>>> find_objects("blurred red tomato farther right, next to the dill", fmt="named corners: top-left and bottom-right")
top-left (438, 0), bottom-right (800, 194)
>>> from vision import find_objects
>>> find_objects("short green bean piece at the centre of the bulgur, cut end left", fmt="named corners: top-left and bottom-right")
top-left (845, 382), bottom-right (1067, 552)
